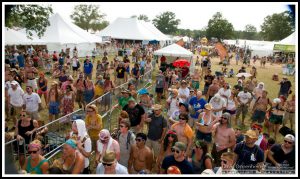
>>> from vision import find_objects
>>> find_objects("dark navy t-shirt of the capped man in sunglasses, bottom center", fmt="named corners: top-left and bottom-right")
top-left (161, 155), bottom-right (194, 174)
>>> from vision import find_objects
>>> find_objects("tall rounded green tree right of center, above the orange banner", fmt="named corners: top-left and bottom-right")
top-left (206, 12), bottom-right (234, 41)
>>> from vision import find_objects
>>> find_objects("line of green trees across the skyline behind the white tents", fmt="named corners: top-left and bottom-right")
top-left (5, 5), bottom-right (295, 41)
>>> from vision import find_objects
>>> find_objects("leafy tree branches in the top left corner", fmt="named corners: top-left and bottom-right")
top-left (5, 5), bottom-right (53, 38)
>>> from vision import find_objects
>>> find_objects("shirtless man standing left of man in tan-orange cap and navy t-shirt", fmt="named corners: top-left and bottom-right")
top-left (211, 112), bottom-right (236, 166)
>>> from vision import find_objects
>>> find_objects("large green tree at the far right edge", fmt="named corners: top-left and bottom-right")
top-left (261, 11), bottom-right (295, 41)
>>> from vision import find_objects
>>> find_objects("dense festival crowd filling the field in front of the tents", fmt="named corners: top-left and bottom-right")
top-left (5, 40), bottom-right (295, 174)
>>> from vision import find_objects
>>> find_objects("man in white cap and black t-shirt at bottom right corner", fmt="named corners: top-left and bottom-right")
top-left (267, 134), bottom-right (295, 173)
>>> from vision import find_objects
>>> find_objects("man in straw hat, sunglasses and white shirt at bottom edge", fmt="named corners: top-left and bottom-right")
top-left (96, 151), bottom-right (128, 174)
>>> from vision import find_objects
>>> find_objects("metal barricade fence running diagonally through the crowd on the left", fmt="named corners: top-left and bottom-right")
top-left (5, 66), bottom-right (151, 173)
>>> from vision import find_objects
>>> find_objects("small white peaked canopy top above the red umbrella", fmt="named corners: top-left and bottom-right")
top-left (153, 44), bottom-right (193, 58)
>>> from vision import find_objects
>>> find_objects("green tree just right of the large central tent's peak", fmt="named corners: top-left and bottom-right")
top-left (153, 11), bottom-right (180, 34)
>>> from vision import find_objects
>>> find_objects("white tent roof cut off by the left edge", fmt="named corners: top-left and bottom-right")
top-left (5, 28), bottom-right (45, 45)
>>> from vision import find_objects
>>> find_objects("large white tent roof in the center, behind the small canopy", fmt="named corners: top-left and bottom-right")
top-left (98, 18), bottom-right (168, 41)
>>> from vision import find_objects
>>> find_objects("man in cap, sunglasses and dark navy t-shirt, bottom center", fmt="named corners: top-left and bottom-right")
top-left (160, 142), bottom-right (194, 174)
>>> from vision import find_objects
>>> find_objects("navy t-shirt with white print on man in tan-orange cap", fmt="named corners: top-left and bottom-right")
top-left (234, 142), bottom-right (264, 173)
